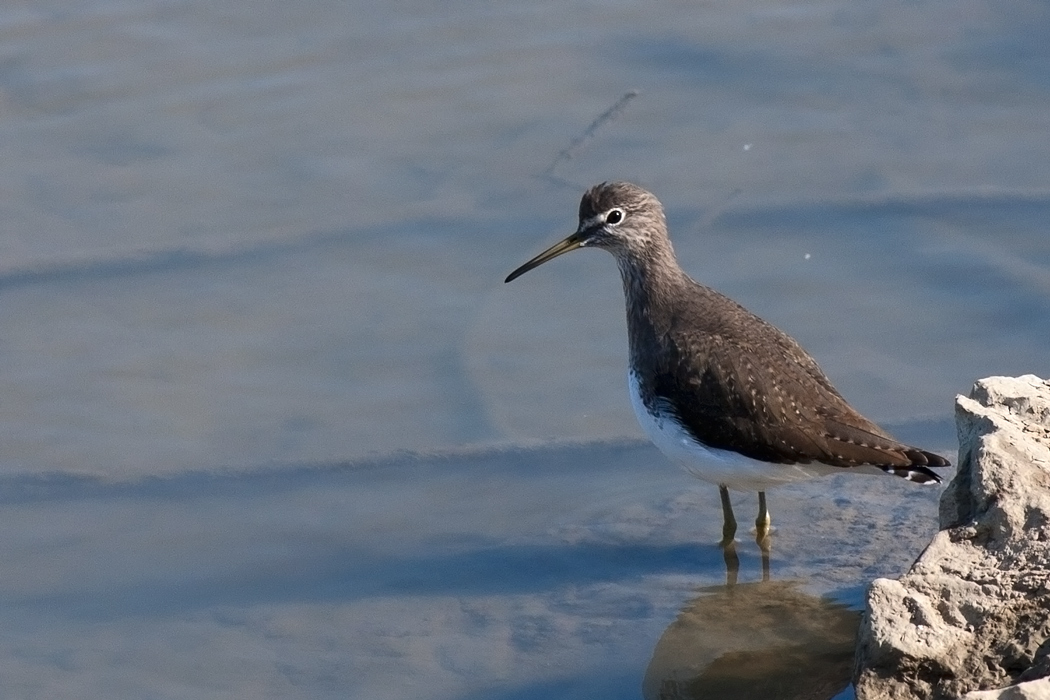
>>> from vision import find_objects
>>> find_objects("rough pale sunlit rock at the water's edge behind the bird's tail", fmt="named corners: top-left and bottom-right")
top-left (855, 375), bottom-right (1050, 700)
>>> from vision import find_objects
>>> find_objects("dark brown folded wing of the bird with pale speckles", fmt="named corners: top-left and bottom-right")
top-left (650, 331), bottom-right (947, 474)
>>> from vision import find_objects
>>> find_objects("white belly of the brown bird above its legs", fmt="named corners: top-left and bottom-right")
top-left (627, 372), bottom-right (840, 491)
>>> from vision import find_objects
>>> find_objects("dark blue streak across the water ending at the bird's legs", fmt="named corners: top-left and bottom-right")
top-left (14, 543), bottom-right (720, 619)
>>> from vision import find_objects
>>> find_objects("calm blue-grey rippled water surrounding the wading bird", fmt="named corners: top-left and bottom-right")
top-left (0, 0), bottom-right (1050, 698)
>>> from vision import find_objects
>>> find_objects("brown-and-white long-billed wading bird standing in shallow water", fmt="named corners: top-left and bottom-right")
top-left (505, 182), bottom-right (950, 573)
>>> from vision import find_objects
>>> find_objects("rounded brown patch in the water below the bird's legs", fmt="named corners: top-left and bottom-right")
top-left (643, 574), bottom-right (860, 700)
